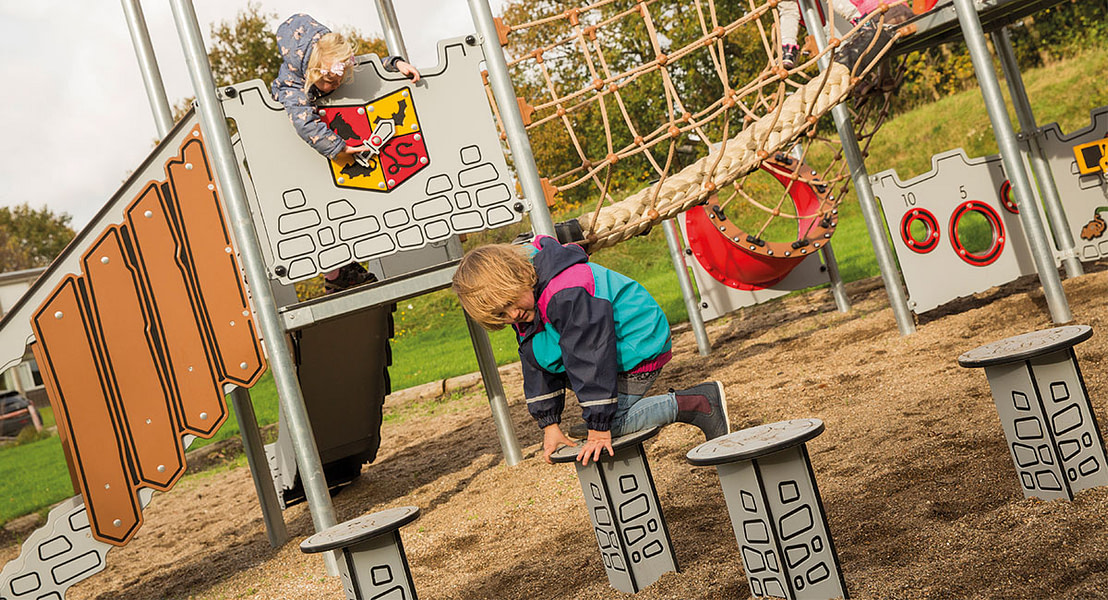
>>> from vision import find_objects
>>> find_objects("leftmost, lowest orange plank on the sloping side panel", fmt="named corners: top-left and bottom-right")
top-left (32, 280), bottom-right (142, 546)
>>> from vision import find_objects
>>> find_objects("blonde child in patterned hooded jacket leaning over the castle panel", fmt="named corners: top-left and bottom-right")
top-left (269, 13), bottom-right (420, 292)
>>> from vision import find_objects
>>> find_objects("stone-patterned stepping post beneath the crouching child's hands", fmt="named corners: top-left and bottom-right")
top-left (551, 427), bottom-right (679, 593)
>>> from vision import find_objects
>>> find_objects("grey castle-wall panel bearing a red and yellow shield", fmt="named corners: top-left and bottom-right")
top-left (220, 39), bottom-right (522, 283)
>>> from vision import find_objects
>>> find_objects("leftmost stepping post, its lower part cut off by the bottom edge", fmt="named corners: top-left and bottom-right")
top-left (300, 506), bottom-right (419, 600)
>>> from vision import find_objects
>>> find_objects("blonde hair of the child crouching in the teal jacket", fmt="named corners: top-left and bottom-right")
top-left (451, 244), bottom-right (538, 331)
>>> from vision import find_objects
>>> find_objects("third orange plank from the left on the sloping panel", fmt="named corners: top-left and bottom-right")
top-left (127, 184), bottom-right (227, 437)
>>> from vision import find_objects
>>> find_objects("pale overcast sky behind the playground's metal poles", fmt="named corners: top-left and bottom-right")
top-left (0, 0), bottom-right (503, 230)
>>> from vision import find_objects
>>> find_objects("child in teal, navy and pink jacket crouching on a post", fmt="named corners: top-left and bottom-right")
top-left (453, 236), bottom-right (730, 465)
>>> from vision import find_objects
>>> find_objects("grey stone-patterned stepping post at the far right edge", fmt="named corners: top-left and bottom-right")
top-left (958, 325), bottom-right (1108, 500)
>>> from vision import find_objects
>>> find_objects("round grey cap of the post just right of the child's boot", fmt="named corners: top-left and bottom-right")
top-left (686, 418), bottom-right (823, 466)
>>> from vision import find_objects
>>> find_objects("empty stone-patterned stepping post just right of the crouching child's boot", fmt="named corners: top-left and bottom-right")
top-left (687, 418), bottom-right (850, 600)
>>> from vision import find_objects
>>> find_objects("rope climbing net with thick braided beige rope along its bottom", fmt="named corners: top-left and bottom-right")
top-left (497, 0), bottom-right (903, 250)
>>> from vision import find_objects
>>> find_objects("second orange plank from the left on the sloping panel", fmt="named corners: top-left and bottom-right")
top-left (82, 226), bottom-right (185, 490)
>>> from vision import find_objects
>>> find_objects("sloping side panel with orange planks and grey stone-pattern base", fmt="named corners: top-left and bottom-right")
top-left (0, 119), bottom-right (266, 599)
